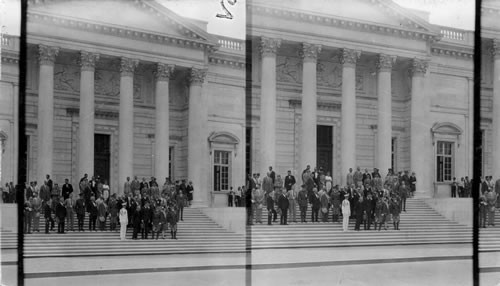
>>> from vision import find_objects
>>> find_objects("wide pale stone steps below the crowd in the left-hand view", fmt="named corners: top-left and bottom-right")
top-left (1, 208), bottom-right (245, 258)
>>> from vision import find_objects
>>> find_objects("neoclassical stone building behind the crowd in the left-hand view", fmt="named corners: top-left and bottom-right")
top-left (0, 1), bottom-right (245, 205)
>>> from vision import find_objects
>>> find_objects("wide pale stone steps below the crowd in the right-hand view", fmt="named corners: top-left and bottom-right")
top-left (250, 199), bottom-right (470, 249)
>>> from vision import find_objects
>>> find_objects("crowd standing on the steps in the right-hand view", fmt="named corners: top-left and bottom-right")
top-left (245, 165), bottom-right (417, 231)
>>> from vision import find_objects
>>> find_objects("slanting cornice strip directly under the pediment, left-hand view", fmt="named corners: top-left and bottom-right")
top-left (27, 12), bottom-right (219, 52)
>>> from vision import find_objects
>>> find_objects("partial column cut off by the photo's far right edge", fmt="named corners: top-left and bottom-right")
top-left (491, 39), bottom-right (500, 180)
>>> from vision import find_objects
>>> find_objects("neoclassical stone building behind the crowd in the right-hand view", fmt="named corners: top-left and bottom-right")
top-left (247, 0), bottom-right (473, 197)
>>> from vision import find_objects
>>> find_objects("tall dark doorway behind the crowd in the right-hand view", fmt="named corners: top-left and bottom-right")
top-left (316, 125), bottom-right (333, 174)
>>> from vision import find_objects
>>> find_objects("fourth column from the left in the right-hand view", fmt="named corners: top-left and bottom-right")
top-left (375, 54), bottom-right (396, 172)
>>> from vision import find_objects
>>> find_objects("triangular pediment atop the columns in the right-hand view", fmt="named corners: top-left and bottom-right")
top-left (252, 0), bottom-right (436, 33)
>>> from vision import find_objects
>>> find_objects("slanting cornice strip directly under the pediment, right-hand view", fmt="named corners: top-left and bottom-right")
top-left (247, 4), bottom-right (441, 42)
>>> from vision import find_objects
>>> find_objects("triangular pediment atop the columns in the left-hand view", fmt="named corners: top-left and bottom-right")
top-left (28, 0), bottom-right (216, 43)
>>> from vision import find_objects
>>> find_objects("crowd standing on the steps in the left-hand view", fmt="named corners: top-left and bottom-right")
top-left (19, 174), bottom-right (194, 240)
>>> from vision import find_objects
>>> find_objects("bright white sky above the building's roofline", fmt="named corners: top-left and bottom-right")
top-left (0, 0), bottom-right (474, 36)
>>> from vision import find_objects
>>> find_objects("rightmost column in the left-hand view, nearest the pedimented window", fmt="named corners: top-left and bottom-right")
top-left (187, 68), bottom-right (209, 206)
